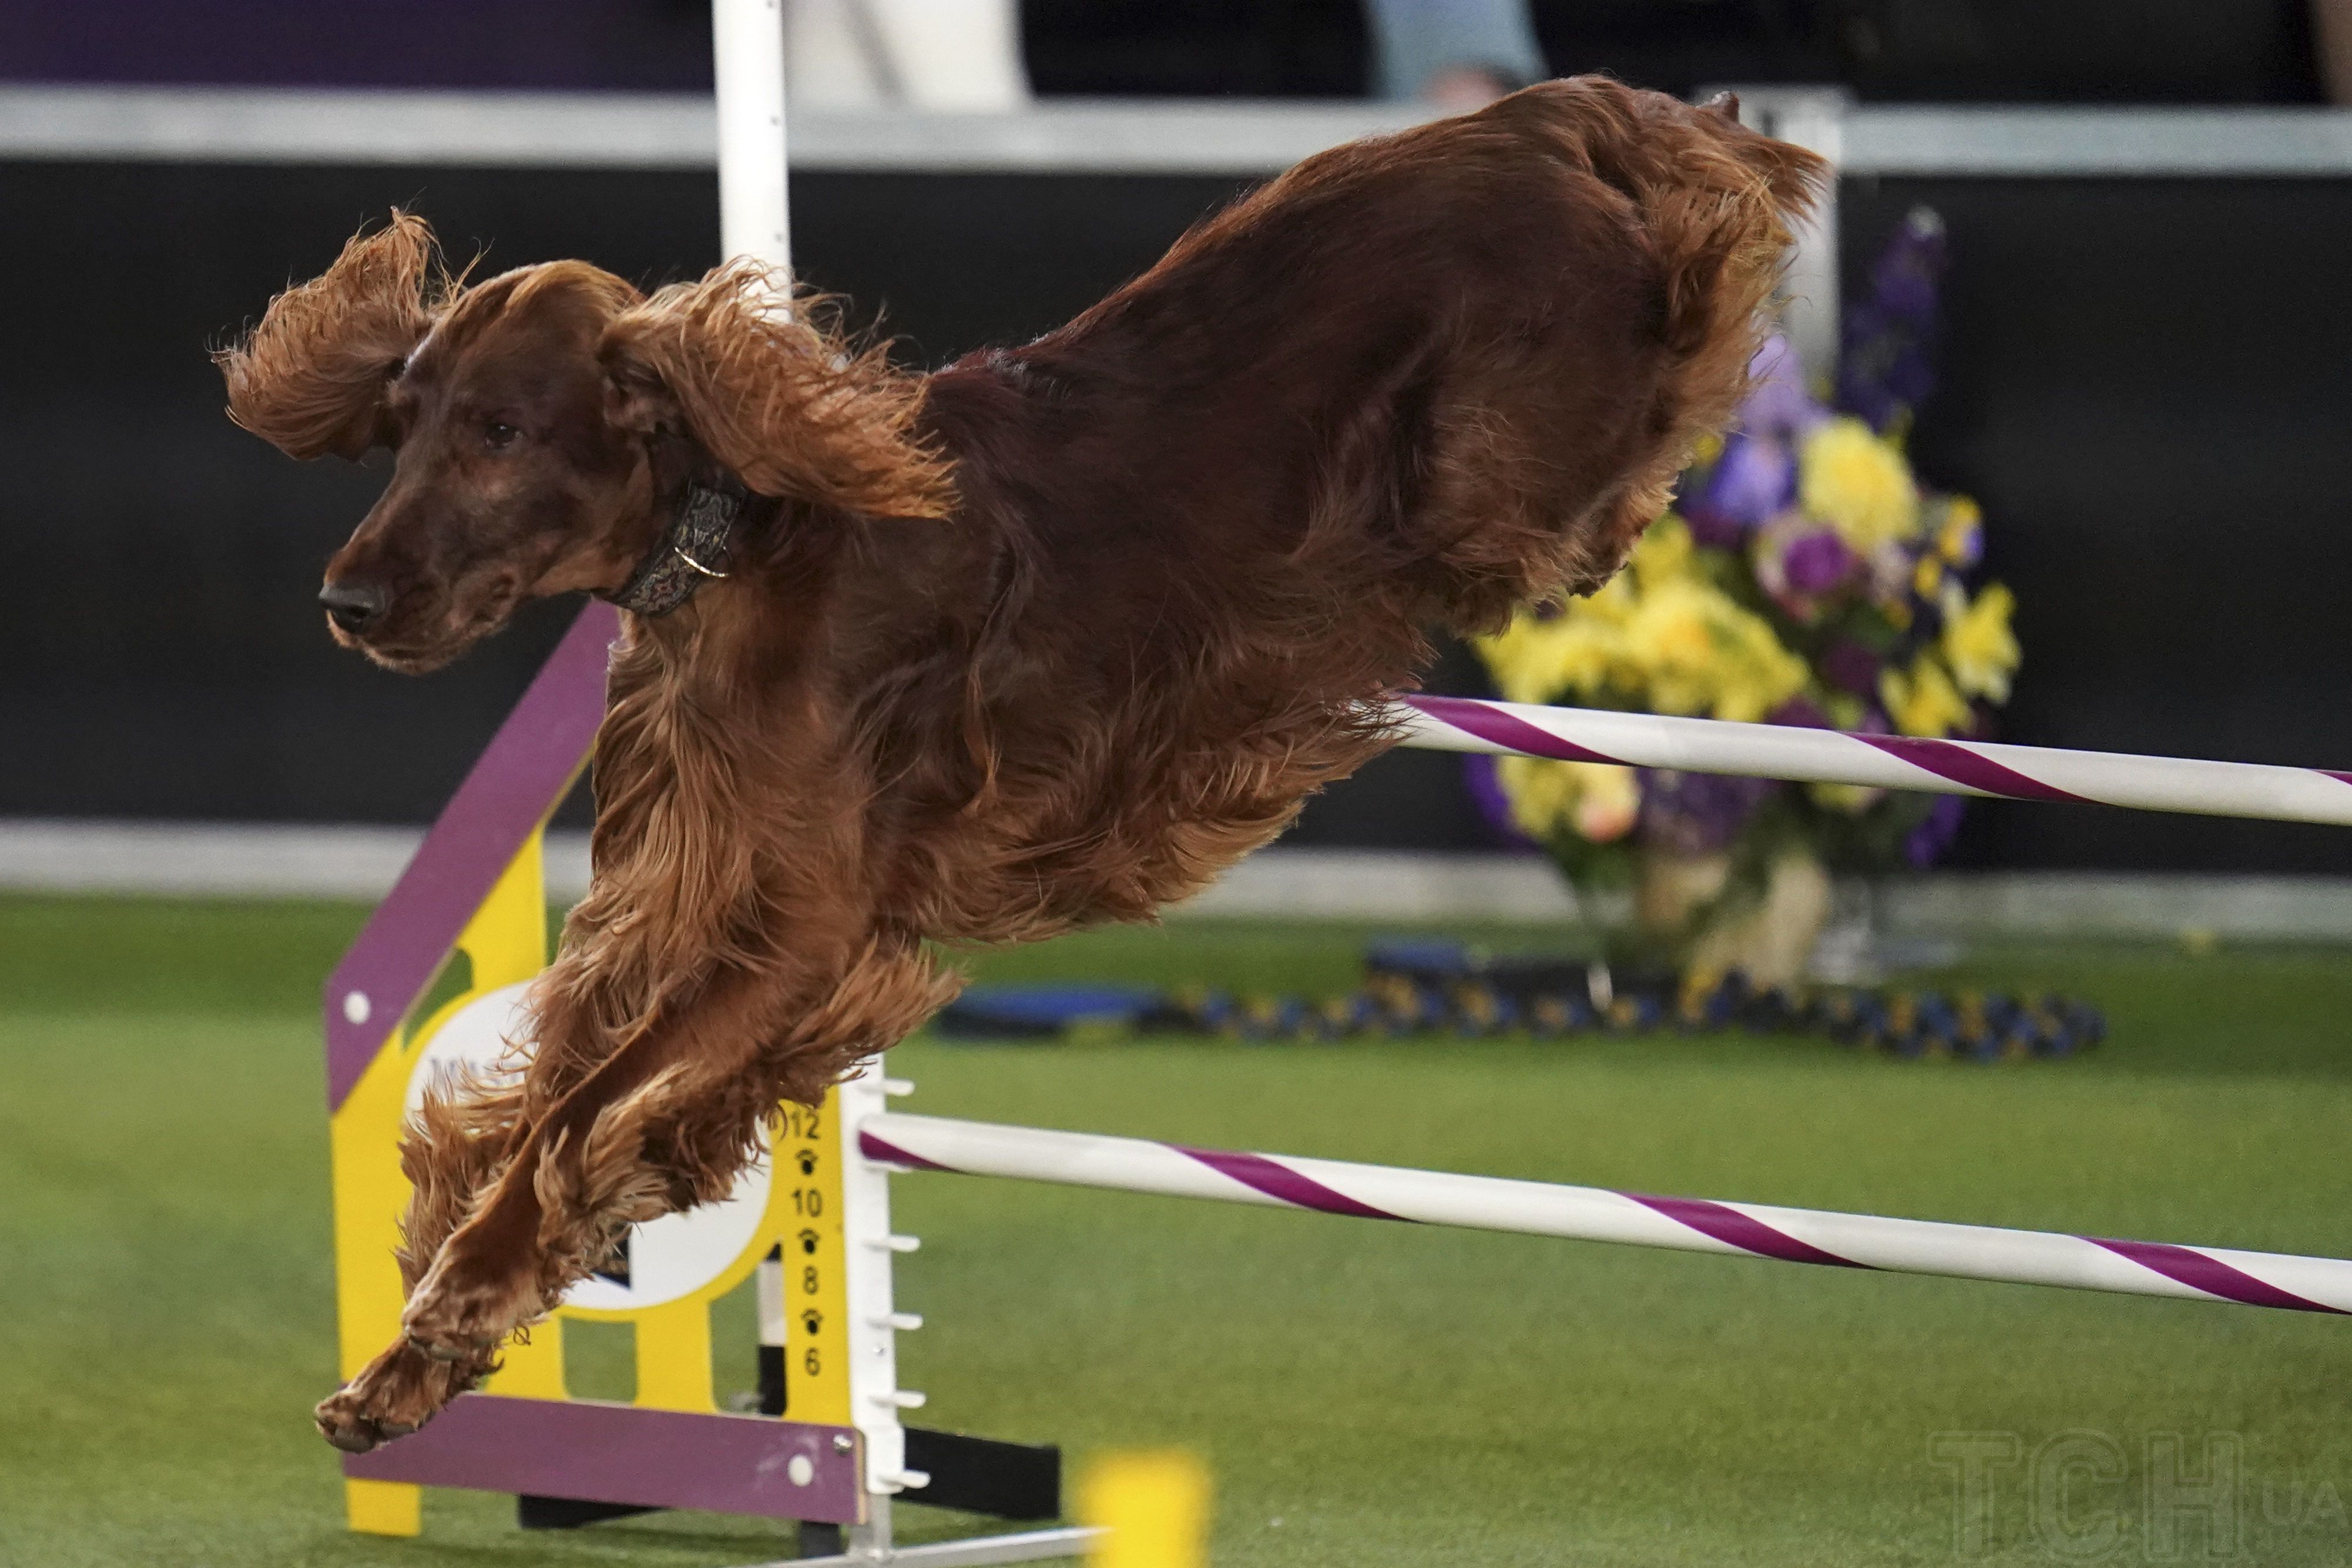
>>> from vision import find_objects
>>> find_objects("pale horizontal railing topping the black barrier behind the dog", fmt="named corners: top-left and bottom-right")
top-left (0, 85), bottom-right (2352, 179)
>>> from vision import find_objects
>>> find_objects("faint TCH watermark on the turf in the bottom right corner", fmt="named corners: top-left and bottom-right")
top-left (1926, 1432), bottom-right (2352, 1563)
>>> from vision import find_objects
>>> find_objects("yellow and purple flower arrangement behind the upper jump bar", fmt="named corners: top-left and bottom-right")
top-left (1479, 209), bottom-right (2018, 957)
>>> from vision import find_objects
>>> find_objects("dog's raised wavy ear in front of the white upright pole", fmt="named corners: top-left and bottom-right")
top-left (598, 261), bottom-right (955, 517)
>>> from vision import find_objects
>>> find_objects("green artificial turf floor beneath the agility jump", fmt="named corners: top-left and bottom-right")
top-left (0, 898), bottom-right (2352, 1568)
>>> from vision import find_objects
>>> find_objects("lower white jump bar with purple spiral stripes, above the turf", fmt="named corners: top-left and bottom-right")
top-left (858, 1114), bottom-right (2352, 1314)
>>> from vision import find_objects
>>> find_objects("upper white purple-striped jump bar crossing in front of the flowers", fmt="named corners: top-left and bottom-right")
top-left (1390, 696), bottom-right (2352, 825)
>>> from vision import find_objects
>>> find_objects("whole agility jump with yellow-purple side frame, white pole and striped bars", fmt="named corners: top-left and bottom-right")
top-left (289, 0), bottom-right (2352, 1568)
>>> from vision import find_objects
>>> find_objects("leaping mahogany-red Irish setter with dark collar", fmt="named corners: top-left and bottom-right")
top-left (221, 78), bottom-right (1823, 1451)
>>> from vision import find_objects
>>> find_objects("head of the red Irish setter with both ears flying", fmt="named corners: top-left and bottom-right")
top-left (219, 214), bottom-right (952, 670)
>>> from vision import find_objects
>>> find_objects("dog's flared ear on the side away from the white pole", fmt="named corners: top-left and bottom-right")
top-left (214, 209), bottom-right (452, 458)
